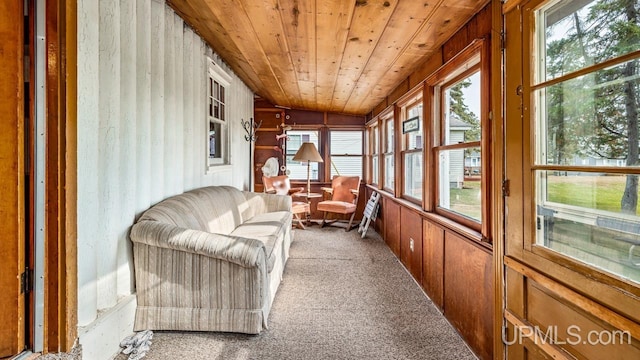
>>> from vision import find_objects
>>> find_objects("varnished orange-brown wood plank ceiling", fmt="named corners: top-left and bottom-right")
top-left (168, 0), bottom-right (488, 114)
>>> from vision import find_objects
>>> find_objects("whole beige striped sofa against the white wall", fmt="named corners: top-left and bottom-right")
top-left (130, 186), bottom-right (292, 334)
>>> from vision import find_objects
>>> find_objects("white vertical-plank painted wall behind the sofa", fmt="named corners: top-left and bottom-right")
top-left (78, 0), bottom-right (253, 359)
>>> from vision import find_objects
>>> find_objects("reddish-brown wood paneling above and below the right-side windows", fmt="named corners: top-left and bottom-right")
top-left (367, 6), bottom-right (494, 359)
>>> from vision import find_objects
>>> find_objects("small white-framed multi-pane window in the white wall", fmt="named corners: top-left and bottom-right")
top-left (207, 58), bottom-right (231, 167)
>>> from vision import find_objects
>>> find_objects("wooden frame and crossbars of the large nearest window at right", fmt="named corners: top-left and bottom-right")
top-left (507, 0), bottom-right (640, 296)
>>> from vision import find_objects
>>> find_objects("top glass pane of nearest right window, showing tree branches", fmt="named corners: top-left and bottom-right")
top-left (536, 0), bottom-right (640, 83)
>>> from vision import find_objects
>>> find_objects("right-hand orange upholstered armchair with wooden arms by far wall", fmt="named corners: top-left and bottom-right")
top-left (318, 176), bottom-right (360, 231)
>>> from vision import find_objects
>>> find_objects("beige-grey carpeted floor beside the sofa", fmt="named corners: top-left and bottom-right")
top-left (116, 225), bottom-right (476, 360)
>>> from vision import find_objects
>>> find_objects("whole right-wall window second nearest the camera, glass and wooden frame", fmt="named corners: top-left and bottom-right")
top-left (428, 40), bottom-right (489, 235)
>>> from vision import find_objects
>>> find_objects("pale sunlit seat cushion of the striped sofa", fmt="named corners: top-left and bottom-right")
top-left (231, 211), bottom-right (291, 272)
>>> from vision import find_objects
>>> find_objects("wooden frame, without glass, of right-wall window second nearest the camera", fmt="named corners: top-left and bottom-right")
top-left (425, 39), bottom-right (492, 243)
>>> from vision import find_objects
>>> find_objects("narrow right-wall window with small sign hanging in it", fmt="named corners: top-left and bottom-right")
top-left (401, 89), bottom-right (424, 202)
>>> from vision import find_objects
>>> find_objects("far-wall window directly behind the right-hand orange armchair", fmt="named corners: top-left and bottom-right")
top-left (329, 130), bottom-right (362, 178)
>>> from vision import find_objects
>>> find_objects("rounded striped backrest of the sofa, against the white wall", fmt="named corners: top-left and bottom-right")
top-left (138, 186), bottom-right (246, 234)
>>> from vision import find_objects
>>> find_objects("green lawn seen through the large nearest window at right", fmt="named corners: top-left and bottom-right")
top-left (547, 176), bottom-right (640, 214)
